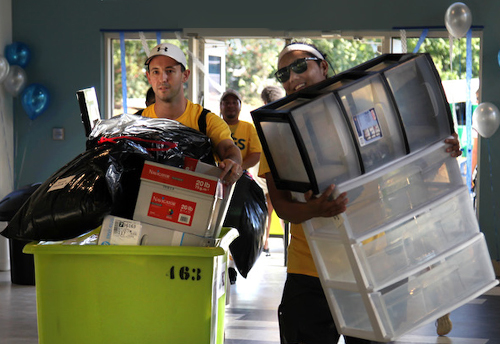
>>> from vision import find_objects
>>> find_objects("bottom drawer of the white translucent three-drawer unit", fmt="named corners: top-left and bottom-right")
top-left (324, 233), bottom-right (497, 342)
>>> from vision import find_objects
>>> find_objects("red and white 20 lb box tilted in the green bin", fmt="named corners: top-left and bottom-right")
top-left (133, 161), bottom-right (224, 237)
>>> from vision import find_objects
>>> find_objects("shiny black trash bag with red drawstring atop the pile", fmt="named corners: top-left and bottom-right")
top-left (87, 114), bottom-right (215, 219)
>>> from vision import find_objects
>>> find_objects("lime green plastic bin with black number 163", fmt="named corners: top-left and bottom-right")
top-left (24, 243), bottom-right (227, 344)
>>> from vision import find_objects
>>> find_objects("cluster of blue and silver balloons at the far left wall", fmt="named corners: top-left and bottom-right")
top-left (0, 42), bottom-right (50, 120)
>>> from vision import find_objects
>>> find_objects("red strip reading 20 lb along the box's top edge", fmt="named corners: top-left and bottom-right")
top-left (141, 164), bottom-right (217, 195)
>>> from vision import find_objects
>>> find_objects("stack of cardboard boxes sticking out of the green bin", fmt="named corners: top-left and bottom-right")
top-left (98, 161), bottom-right (233, 246)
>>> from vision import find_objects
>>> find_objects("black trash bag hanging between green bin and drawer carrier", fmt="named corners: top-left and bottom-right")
top-left (224, 172), bottom-right (267, 278)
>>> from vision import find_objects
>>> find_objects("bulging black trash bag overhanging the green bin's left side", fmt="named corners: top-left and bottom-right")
top-left (1, 145), bottom-right (117, 241)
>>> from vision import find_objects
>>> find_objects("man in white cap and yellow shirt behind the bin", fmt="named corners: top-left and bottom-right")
top-left (142, 43), bottom-right (242, 184)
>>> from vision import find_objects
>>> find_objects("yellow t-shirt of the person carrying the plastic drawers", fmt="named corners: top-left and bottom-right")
top-left (259, 154), bottom-right (319, 277)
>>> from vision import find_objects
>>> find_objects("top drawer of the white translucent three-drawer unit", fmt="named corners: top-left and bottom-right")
top-left (309, 142), bottom-right (463, 238)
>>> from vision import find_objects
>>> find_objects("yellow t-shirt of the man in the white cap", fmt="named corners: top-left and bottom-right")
top-left (142, 99), bottom-right (231, 147)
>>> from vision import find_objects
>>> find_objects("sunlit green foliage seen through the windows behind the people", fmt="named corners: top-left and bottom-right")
top-left (113, 38), bottom-right (480, 112)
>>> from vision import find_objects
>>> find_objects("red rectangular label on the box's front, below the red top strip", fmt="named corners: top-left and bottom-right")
top-left (148, 192), bottom-right (196, 226)
